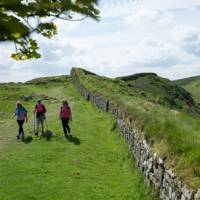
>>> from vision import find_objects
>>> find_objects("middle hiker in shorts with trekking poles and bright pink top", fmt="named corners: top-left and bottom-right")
top-left (33, 100), bottom-right (46, 136)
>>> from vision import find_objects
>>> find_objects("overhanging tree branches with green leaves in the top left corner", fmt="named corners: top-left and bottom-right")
top-left (0, 0), bottom-right (99, 60)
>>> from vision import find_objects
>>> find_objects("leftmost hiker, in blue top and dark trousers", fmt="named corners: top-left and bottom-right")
top-left (12, 101), bottom-right (28, 140)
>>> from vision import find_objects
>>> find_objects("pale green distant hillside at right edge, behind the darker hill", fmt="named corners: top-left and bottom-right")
top-left (174, 76), bottom-right (200, 103)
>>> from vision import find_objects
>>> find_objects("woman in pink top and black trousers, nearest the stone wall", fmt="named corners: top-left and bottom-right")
top-left (60, 101), bottom-right (72, 138)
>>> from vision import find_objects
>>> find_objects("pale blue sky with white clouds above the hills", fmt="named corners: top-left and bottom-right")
top-left (0, 0), bottom-right (200, 82)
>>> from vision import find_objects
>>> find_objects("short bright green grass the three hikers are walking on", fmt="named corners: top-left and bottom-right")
top-left (0, 81), bottom-right (156, 200)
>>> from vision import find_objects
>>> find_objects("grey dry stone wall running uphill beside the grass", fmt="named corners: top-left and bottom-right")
top-left (71, 70), bottom-right (200, 200)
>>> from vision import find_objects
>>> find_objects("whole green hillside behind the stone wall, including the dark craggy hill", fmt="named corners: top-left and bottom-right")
top-left (74, 69), bottom-right (200, 188)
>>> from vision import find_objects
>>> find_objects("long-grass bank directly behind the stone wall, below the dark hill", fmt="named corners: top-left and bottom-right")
top-left (72, 69), bottom-right (200, 188)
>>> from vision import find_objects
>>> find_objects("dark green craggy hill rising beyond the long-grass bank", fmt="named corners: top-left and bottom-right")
top-left (118, 73), bottom-right (200, 113)
